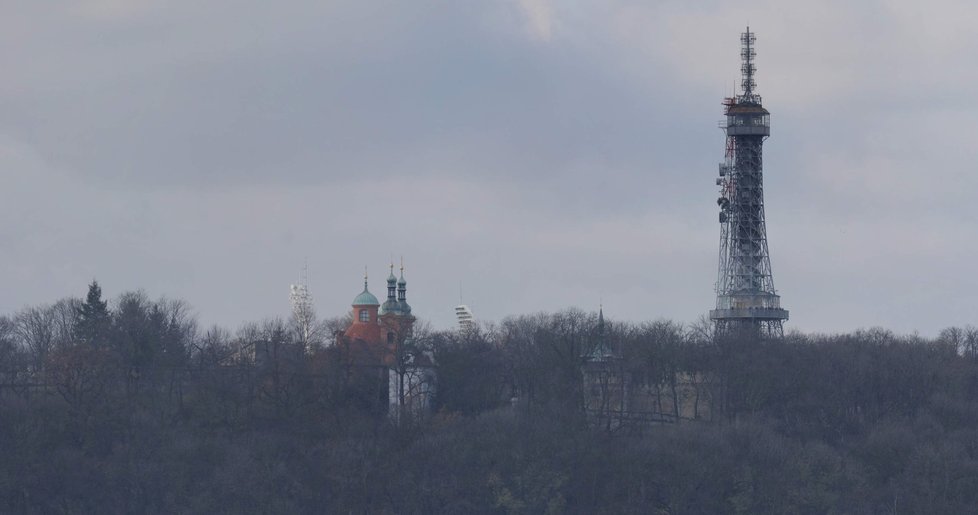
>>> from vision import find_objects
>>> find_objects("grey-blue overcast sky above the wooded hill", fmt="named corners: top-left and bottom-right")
top-left (0, 0), bottom-right (978, 336)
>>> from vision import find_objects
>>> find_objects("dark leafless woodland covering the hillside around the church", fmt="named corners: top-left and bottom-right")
top-left (0, 283), bottom-right (978, 514)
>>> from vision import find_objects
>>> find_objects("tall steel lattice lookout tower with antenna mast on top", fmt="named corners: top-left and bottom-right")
top-left (710, 27), bottom-right (788, 337)
